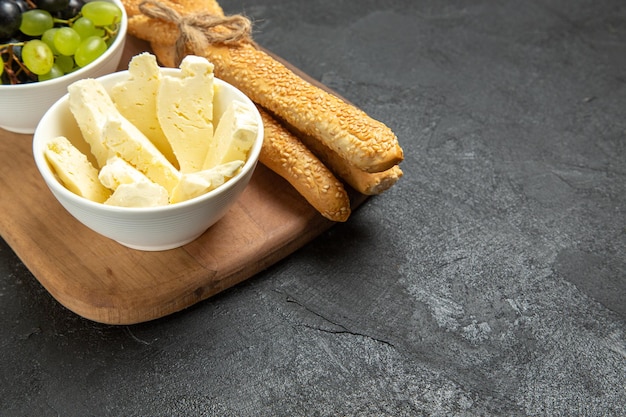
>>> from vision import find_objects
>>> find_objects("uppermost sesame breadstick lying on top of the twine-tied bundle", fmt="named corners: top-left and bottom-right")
top-left (125, 0), bottom-right (403, 172)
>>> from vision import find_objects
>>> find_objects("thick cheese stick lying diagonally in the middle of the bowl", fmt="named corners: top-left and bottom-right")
top-left (103, 116), bottom-right (180, 193)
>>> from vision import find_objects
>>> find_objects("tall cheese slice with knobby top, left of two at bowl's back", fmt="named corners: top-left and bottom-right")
top-left (110, 52), bottom-right (178, 166)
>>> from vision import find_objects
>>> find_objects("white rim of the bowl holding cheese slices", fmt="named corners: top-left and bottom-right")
top-left (32, 67), bottom-right (264, 215)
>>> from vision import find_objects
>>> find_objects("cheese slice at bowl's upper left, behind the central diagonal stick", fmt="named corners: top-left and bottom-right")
top-left (67, 78), bottom-right (119, 168)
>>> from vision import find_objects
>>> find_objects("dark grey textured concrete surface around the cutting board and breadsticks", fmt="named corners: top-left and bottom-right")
top-left (0, 0), bottom-right (626, 416)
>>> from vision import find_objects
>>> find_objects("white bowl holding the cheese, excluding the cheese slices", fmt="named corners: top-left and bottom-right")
top-left (33, 68), bottom-right (263, 251)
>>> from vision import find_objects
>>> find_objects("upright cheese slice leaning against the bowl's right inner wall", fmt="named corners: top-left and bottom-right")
top-left (202, 101), bottom-right (259, 169)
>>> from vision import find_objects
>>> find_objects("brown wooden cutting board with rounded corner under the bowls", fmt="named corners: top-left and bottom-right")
top-left (0, 37), bottom-right (365, 324)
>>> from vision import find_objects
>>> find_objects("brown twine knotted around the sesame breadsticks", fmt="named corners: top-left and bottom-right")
top-left (139, 0), bottom-right (254, 65)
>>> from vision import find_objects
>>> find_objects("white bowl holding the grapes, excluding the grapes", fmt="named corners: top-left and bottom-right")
top-left (0, 0), bottom-right (128, 134)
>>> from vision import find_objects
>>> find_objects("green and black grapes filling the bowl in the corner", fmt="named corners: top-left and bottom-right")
top-left (0, 0), bottom-right (122, 84)
